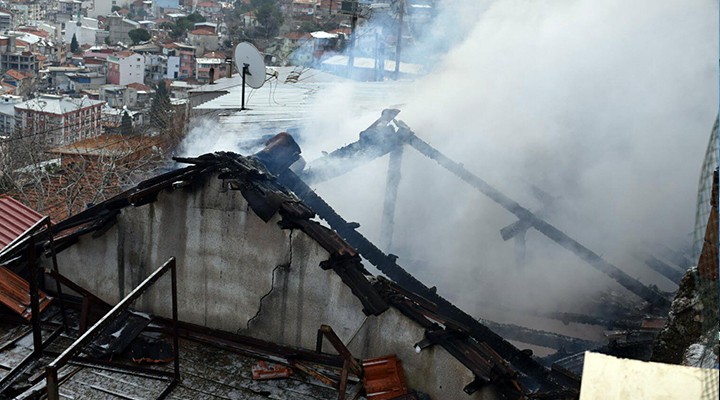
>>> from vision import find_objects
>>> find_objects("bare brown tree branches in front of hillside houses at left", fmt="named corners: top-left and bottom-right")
top-left (0, 97), bottom-right (176, 221)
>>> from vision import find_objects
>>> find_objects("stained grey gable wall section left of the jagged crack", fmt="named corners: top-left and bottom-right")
top-left (58, 178), bottom-right (292, 332)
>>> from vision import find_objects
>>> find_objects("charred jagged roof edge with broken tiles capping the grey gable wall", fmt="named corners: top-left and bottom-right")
top-left (36, 152), bottom-right (544, 398)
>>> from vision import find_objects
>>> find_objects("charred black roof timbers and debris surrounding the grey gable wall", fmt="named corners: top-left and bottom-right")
top-left (0, 110), bottom-right (678, 399)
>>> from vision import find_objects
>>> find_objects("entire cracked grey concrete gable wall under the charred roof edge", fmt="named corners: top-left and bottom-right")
top-left (50, 173), bottom-right (497, 399)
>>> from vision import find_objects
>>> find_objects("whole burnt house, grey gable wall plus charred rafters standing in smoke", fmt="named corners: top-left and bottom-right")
top-left (0, 110), bottom-right (700, 399)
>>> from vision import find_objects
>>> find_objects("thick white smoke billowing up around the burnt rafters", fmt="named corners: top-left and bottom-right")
top-left (296, 0), bottom-right (718, 334)
